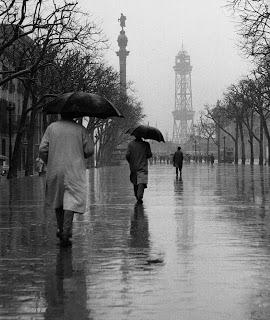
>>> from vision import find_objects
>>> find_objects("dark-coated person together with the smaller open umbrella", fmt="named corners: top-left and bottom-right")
top-left (126, 125), bottom-right (164, 204)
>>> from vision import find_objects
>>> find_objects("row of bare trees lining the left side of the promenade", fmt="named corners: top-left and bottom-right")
top-left (0, 0), bottom-right (143, 178)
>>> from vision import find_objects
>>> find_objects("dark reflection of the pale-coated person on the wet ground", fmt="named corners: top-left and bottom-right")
top-left (44, 248), bottom-right (91, 320)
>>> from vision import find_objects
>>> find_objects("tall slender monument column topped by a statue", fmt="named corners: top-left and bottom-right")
top-left (116, 13), bottom-right (129, 97)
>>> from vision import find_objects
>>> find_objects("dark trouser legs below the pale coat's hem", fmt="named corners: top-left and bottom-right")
top-left (55, 207), bottom-right (74, 238)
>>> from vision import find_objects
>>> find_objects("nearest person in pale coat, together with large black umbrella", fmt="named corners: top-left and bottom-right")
top-left (39, 92), bottom-right (122, 247)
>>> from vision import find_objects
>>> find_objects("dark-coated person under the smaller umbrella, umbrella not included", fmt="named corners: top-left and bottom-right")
top-left (126, 137), bottom-right (152, 204)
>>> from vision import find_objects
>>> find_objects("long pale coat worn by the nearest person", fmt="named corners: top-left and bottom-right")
top-left (39, 120), bottom-right (94, 213)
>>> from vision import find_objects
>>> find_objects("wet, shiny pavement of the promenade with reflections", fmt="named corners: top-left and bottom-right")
top-left (0, 164), bottom-right (270, 320)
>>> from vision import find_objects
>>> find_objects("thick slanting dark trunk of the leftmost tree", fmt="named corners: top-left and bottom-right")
top-left (7, 84), bottom-right (30, 179)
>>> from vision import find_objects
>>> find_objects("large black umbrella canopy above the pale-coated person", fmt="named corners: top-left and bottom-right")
top-left (43, 91), bottom-right (123, 119)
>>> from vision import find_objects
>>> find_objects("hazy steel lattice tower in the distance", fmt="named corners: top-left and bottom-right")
top-left (172, 45), bottom-right (195, 143)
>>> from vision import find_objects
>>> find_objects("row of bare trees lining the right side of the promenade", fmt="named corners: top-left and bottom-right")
top-left (193, 0), bottom-right (270, 165)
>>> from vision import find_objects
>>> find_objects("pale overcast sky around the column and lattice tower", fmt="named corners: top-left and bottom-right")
top-left (79, 0), bottom-right (250, 137)
